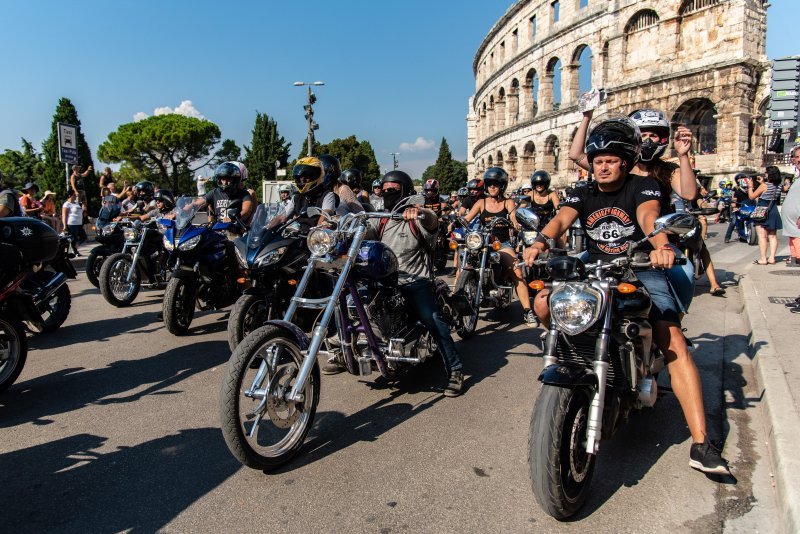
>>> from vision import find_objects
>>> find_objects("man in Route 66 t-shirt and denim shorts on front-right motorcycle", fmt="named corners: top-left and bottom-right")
top-left (525, 118), bottom-right (729, 474)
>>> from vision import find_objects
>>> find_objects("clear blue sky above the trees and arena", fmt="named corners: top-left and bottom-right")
top-left (0, 0), bottom-right (800, 182)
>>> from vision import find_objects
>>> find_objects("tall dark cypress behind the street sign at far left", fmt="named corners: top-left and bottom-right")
top-left (38, 98), bottom-right (100, 209)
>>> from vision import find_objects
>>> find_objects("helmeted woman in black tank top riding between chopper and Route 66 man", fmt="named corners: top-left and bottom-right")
top-left (465, 167), bottom-right (536, 323)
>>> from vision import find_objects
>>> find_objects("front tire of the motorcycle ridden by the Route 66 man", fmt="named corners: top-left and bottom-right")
top-left (528, 385), bottom-right (595, 520)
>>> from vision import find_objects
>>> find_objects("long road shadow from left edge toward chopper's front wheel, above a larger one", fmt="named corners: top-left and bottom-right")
top-left (0, 341), bottom-right (230, 428)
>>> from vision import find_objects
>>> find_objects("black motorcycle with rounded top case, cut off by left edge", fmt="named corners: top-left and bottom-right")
top-left (0, 217), bottom-right (69, 392)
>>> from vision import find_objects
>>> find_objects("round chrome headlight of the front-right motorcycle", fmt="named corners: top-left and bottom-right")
top-left (550, 282), bottom-right (603, 336)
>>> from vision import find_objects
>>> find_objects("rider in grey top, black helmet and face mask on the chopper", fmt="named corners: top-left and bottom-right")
top-left (373, 171), bottom-right (464, 397)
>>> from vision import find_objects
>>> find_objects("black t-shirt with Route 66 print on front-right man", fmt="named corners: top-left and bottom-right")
top-left (563, 175), bottom-right (661, 261)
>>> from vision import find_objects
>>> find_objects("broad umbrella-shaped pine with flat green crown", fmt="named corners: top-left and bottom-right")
top-left (97, 113), bottom-right (220, 194)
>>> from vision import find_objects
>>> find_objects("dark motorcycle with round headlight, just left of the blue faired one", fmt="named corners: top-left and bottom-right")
top-left (100, 220), bottom-right (170, 308)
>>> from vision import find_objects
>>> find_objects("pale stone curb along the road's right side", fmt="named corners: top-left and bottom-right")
top-left (739, 275), bottom-right (800, 532)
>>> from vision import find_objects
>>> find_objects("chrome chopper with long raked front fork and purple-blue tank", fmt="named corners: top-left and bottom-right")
top-left (220, 196), bottom-right (460, 470)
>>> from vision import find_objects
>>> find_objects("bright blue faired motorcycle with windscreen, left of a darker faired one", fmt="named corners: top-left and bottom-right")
top-left (158, 197), bottom-right (243, 336)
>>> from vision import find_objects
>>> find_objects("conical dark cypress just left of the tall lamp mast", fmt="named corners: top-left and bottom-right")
top-left (244, 111), bottom-right (292, 198)
